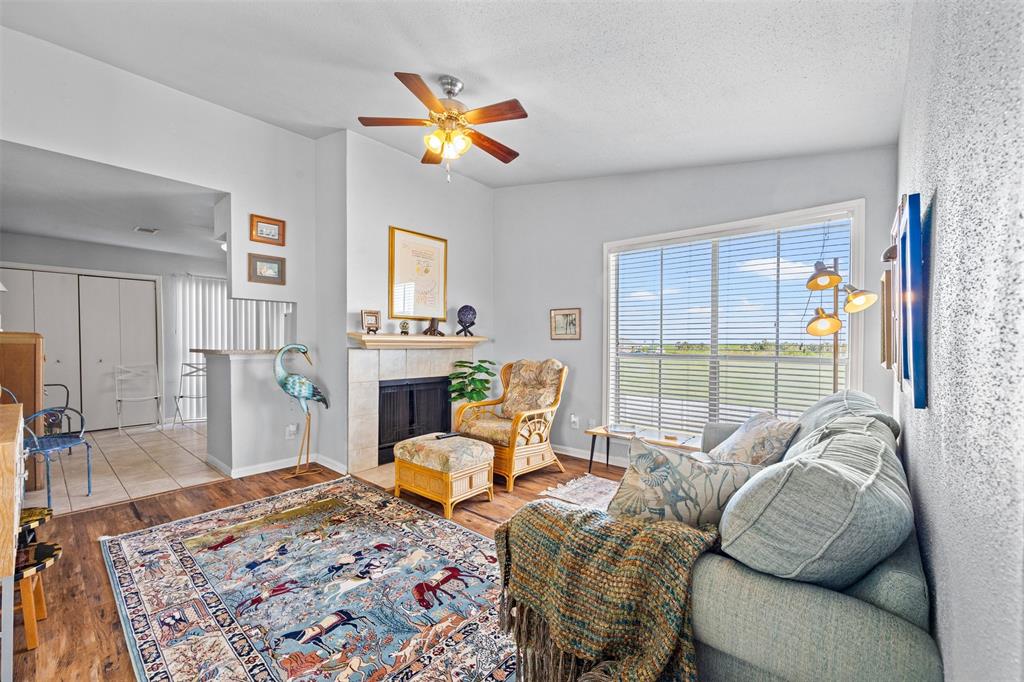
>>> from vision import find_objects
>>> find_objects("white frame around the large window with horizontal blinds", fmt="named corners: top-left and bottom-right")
top-left (601, 198), bottom-right (866, 424)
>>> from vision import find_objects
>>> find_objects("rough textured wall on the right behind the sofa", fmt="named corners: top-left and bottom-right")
top-left (896, 0), bottom-right (1024, 681)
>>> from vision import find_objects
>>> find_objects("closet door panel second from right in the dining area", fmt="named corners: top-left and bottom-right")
top-left (78, 275), bottom-right (121, 431)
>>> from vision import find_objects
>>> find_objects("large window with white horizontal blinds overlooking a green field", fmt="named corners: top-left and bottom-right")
top-left (605, 202), bottom-right (863, 433)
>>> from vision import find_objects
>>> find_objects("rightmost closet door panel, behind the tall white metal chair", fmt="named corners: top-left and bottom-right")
top-left (118, 280), bottom-right (157, 426)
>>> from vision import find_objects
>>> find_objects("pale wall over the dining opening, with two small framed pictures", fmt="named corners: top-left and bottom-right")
top-left (0, 28), bottom-right (315, 339)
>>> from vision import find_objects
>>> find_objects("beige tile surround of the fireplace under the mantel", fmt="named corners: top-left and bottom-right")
top-left (348, 348), bottom-right (473, 472)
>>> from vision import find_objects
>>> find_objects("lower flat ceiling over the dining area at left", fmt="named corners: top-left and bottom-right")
top-left (0, 141), bottom-right (225, 258)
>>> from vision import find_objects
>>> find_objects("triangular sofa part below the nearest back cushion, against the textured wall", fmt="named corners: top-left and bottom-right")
top-left (844, 532), bottom-right (930, 631)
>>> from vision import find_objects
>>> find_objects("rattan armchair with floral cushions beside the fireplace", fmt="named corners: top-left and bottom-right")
top-left (455, 359), bottom-right (568, 493)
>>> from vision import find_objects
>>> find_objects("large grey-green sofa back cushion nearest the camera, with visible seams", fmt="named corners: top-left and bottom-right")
top-left (720, 433), bottom-right (913, 589)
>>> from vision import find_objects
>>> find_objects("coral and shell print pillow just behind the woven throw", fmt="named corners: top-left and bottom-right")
top-left (608, 438), bottom-right (763, 527)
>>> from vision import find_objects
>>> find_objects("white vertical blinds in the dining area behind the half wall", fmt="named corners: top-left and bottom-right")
top-left (173, 275), bottom-right (293, 419)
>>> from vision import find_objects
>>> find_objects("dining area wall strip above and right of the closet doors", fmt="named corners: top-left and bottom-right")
top-left (0, 229), bottom-right (227, 419)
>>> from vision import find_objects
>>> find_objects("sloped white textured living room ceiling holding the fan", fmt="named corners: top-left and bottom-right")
top-left (0, 0), bottom-right (910, 186)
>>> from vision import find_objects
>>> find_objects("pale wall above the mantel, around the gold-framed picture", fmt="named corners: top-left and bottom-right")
top-left (346, 130), bottom-right (499, 339)
